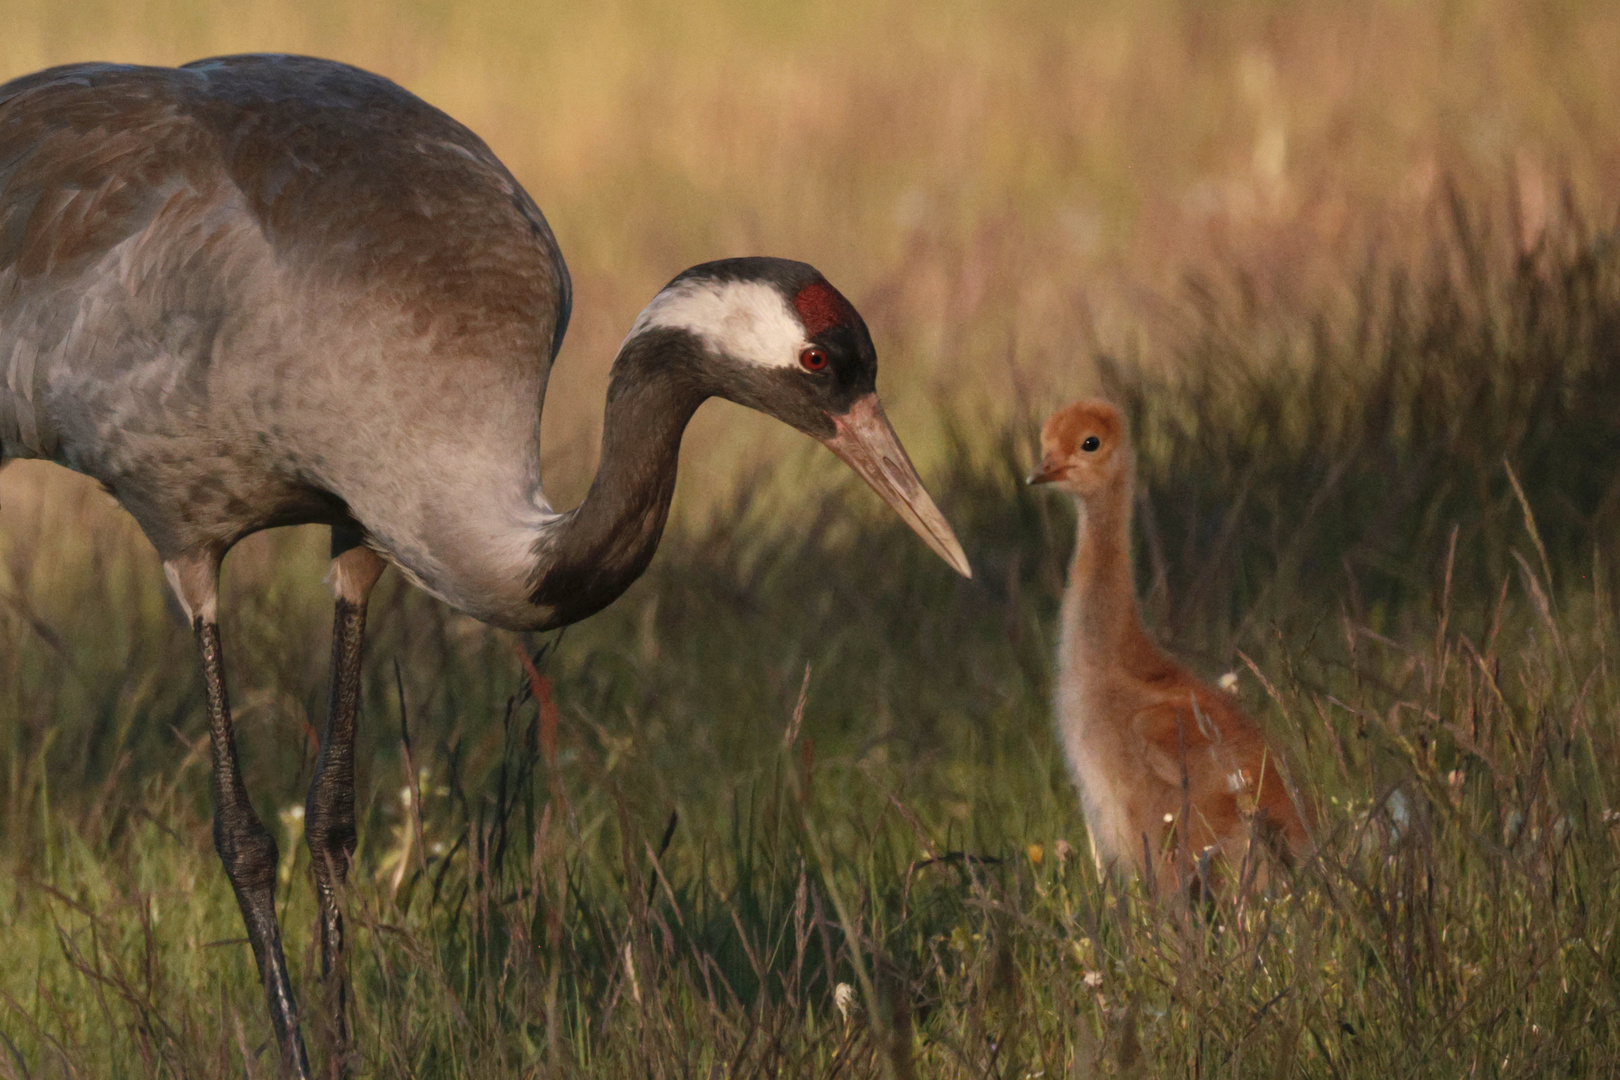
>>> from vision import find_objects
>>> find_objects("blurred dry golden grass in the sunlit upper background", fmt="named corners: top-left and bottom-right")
top-left (0, 0), bottom-right (1620, 514)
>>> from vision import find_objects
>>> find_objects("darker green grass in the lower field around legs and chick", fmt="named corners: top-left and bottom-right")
top-left (0, 190), bottom-right (1620, 1078)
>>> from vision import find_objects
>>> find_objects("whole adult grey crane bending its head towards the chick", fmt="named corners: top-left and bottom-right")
top-left (0, 55), bottom-right (969, 1080)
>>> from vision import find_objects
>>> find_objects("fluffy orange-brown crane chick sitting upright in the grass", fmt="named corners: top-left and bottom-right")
top-left (1029, 400), bottom-right (1306, 886)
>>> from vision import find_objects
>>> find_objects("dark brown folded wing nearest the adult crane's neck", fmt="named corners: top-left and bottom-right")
top-left (180, 55), bottom-right (572, 392)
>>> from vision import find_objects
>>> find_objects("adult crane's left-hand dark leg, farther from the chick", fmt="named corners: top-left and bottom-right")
top-left (164, 552), bottom-right (309, 1080)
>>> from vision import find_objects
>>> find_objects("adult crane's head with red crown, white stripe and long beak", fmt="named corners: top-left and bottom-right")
top-left (627, 257), bottom-right (972, 576)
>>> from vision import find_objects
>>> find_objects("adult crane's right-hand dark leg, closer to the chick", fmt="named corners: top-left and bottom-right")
top-left (305, 528), bottom-right (386, 1077)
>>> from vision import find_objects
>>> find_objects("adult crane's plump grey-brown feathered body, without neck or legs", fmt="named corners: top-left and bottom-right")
top-left (0, 57), bottom-right (570, 615)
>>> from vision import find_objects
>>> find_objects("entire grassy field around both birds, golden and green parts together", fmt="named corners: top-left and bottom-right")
top-left (0, 0), bottom-right (1620, 1080)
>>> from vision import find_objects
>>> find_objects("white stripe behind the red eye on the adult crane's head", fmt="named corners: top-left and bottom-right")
top-left (630, 282), bottom-right (805, 368)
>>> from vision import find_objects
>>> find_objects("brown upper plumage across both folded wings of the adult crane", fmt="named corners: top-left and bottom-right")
top-left (0, 55), bottom-right (572, 416)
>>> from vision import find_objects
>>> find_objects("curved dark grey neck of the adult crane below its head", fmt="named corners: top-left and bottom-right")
top-left (530, 334), bottom-right (710, 627)
